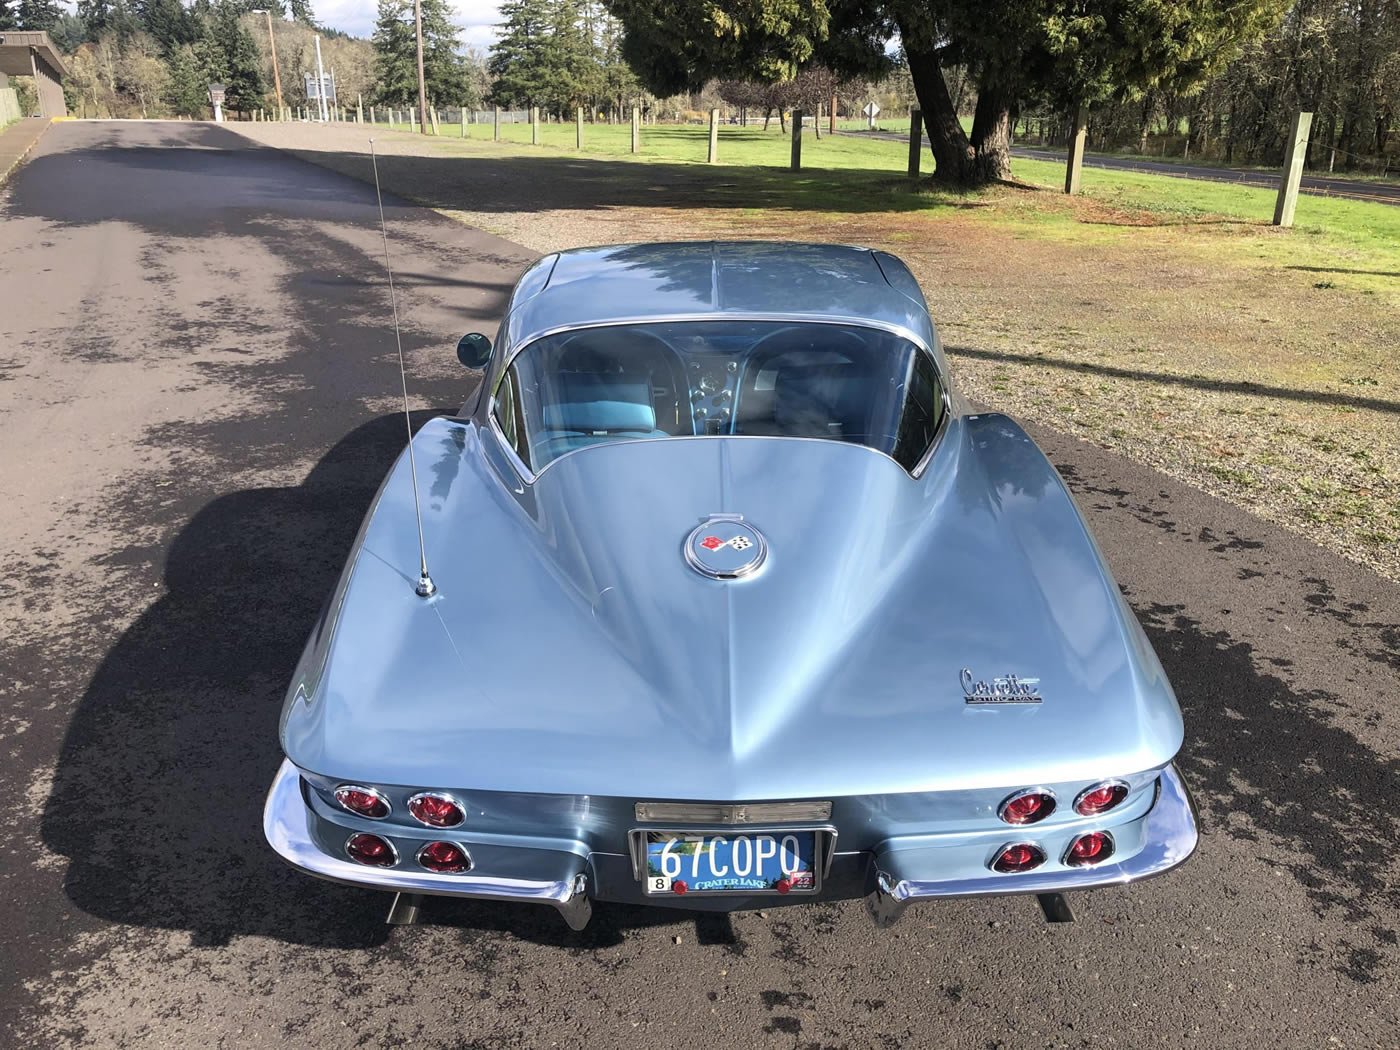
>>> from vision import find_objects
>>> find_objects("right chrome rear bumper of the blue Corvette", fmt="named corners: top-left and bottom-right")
top-left (865, 766), bottom-right (1200, 927)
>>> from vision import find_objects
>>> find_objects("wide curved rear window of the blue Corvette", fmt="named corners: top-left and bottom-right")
top-left (493, 321), bottom-right (944, 470)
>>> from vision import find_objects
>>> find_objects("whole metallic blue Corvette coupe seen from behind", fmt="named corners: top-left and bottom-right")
top-left (265, 242), bottom-right (1197, 928)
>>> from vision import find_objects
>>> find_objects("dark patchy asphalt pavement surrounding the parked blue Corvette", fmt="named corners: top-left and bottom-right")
top-left (0, 122), bottom-right (1400, 1050)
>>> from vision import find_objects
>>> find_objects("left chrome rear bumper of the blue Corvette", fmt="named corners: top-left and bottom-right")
top-left (263, 759), bottom-right (592, 930)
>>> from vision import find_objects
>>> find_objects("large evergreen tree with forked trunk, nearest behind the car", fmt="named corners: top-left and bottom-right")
top-left (605, 0), bottom-right (1285, 183)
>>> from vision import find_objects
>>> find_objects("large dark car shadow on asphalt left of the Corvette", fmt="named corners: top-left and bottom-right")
top-left (42, 413), bottom-right (437, 946)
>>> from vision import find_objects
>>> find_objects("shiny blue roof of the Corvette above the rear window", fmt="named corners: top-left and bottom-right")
top-left (496, 241), bottom-right (942, 368)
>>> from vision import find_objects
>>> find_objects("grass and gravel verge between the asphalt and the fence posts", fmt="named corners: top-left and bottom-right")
top-left (243, 123), bottom-right (1400, 580)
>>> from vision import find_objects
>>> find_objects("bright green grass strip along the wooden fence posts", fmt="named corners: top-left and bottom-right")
top-left (364, 120), bottom-right (1400, 285)
